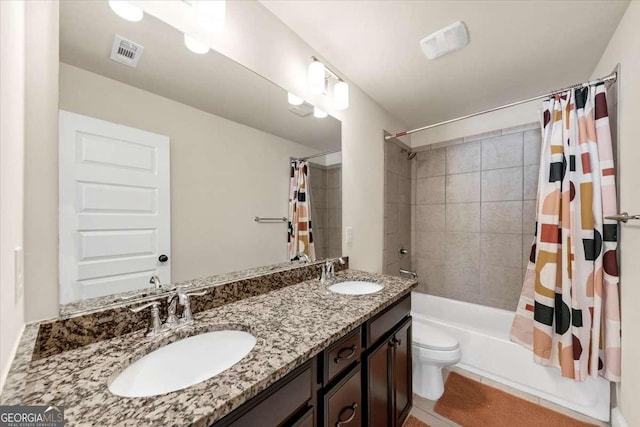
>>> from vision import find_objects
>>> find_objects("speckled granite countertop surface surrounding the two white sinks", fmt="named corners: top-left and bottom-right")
top-left (0, 270), bottom-right (417, 426)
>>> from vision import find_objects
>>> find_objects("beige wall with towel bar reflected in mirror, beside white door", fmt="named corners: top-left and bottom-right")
top-left (60, 64), bottom-right (317, 288)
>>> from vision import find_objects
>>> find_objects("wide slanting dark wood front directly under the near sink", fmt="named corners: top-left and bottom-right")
top-left (222, 363), bottom-right (314, 427)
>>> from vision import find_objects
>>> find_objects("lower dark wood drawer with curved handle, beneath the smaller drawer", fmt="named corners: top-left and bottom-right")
top-left (323, 365), bottom-right (362, 427)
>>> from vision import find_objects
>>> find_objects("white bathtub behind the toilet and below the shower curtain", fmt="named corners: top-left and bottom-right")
top-left (411, 292), bottom-right (610, 421)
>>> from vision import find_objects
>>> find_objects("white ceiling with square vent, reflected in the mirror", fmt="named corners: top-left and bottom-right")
top-left (60, 1), bottom-right (341, 151)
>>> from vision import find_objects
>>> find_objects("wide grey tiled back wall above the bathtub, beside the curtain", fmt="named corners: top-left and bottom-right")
top-left (411, 123), bottom-right (541, 310)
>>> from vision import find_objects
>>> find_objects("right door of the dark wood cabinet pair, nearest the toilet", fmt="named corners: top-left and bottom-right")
top-left (391, 318), bottom-right (413, 427)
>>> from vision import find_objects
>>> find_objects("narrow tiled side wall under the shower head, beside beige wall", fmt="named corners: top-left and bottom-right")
top-left (383, 140), bottom-right (415, 275)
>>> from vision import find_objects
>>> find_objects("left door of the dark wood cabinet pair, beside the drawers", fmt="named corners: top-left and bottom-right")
top-left (365, 340), bottom-right (392, 427)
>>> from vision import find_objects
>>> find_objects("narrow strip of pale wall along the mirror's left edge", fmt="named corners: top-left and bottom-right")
top-left (24, 1), bottom-right (59, 320)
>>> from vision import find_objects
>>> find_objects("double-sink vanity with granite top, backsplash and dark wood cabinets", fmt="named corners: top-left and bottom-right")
top-left (0, 261), bottom-right (417, 427)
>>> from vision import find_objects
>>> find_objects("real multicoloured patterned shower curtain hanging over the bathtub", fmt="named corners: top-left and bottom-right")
top-left (511, 84), bottom-right (620, 381)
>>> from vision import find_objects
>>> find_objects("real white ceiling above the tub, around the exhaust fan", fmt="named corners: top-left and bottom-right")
top-left (262, 0), bottom-right (629, 127)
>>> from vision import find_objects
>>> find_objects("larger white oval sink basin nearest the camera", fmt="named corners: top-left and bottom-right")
top-left (109, 331), bottom-right (256, 397)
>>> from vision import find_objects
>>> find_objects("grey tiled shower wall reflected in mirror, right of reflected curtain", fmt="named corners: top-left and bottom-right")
top-left (309, 163), bottom-right (342, 259)
